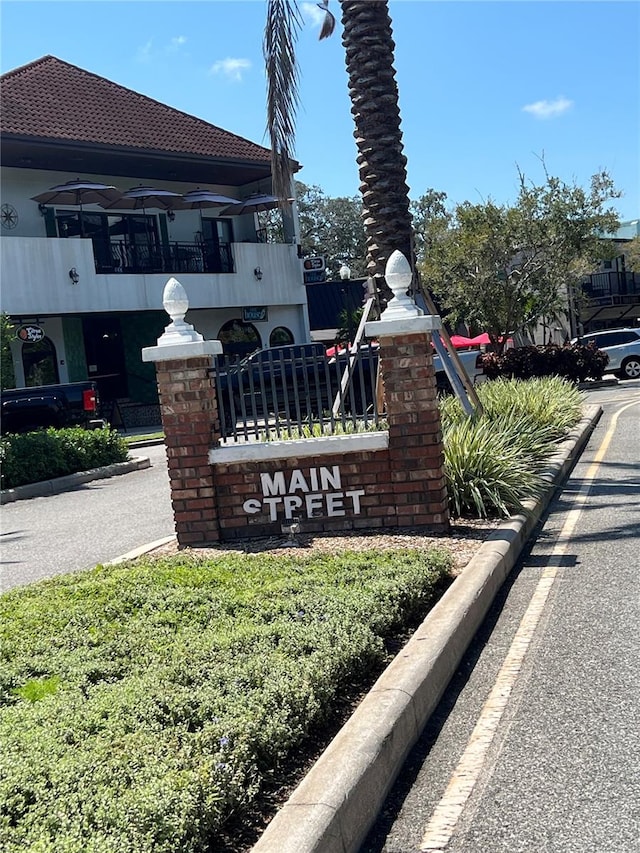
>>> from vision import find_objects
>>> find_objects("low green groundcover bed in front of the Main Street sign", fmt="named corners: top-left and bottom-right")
top-left (0, 549), bottom-right (451, 853)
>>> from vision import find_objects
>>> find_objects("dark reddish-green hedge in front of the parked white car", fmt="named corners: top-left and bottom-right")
top-left (481, 344), bottom-right (609, 382)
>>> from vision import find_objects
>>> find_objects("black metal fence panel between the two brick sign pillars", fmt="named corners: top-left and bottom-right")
top-left (213, 344), bottom-right (382, 441)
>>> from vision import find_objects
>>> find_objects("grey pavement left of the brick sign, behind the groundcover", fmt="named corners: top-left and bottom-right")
top-left (0, 445), bottom-right (174, 591)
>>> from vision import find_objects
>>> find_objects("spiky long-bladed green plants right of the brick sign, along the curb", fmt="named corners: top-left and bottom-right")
top-left (440, 377), bottom-right (582, 518)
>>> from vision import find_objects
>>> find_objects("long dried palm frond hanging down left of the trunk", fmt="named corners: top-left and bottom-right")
top-left (263, 0), bottom-right (302, 199)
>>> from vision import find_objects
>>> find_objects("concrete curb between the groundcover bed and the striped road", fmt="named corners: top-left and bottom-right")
top-left (252, 406), bottom-right (602, 853)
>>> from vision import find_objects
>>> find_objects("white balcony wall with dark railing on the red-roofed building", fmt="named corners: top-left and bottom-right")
top-left (0, 236), bottom-right (306, 316)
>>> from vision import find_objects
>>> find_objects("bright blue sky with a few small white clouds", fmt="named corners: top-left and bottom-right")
top-left (0, 0), bottom-right (640, 220)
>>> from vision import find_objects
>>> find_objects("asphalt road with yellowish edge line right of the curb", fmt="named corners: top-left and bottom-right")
top-left (361, 381), bottom-right (640, 853)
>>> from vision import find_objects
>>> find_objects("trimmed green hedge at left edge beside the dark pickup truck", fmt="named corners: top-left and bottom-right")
top-left (0, 427), bottom-right (129, 489)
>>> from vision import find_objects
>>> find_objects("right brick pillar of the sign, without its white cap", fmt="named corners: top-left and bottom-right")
top-left (379, 332), bottom-right (449, 530)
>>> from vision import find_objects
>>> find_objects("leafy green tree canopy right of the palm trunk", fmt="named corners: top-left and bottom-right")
top-left (414, 169), bottom-right (620, 350)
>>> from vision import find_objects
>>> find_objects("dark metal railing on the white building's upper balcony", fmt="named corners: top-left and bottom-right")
top-left (93, 240), bottom-right (235, 274)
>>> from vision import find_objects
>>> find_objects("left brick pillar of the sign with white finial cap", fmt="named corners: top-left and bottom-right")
top-left (142, 278), bottom-right (222, 547)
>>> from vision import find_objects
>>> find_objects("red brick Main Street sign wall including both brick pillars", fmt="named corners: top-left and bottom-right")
top-left (151, 333), bottom-right (449, 546)
